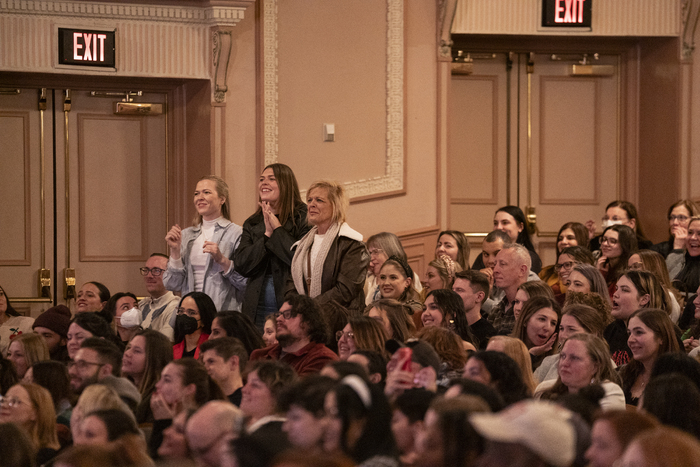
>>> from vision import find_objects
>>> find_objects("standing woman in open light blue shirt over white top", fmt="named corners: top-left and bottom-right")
top-left (163, 175), bottom-right (246, 310)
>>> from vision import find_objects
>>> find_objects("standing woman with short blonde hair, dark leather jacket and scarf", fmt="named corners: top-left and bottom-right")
top-left (285, 181), bottom-right (369, 311)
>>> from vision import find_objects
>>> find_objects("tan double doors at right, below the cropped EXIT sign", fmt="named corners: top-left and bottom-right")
top-left (448, 53), bottom-right (622, 264)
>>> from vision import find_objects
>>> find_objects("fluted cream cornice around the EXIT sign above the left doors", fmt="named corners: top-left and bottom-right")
top-left (0, 0), bottom-right (245, 80)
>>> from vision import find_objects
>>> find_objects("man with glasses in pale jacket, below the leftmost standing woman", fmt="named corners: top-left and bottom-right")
top-left (139, 253), bottom-right (179, 341)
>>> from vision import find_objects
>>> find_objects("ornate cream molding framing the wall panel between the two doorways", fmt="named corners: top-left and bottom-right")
top-left (263, 0), bottom-right (405, 202)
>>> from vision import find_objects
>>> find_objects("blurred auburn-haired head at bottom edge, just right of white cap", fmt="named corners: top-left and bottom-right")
top-left (586, 410), bottom-right (659, 467)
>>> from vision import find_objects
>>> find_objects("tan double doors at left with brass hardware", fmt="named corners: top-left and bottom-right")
top-left (0, 87), bottom-right (168, 315)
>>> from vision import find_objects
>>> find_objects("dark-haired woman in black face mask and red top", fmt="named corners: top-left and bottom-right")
top-left (173, 292), bottom-right (216, 360)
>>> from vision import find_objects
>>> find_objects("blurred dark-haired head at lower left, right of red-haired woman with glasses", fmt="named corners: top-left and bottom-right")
top-left (73, 409), bottom-right (141, 451)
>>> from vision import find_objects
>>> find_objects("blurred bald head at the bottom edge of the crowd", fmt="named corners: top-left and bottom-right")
top-left (186, 401), bottom-right (243, 467)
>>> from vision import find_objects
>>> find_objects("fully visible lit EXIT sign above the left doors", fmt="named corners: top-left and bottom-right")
top-left (58, 28), bottom-right (115, 68)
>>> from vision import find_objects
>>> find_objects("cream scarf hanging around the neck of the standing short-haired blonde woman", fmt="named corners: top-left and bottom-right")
top-left (292, 223), bottom-right (341, 298)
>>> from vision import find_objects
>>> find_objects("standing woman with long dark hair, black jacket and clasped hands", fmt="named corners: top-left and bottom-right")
top-left (233, 164), bottom-right (311, 331)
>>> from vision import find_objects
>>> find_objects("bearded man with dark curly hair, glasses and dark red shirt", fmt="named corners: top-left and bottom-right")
top-left (250, 295), bottom-right (338, 376)
